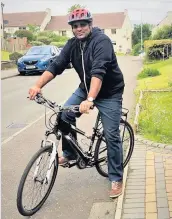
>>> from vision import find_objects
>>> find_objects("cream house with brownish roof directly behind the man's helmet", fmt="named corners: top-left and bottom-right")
top-left (45, 10), bottom-right (132, 53)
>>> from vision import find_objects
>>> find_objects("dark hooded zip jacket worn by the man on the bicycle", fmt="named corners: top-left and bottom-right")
top-left (47, 28), bottom-right (124, 98)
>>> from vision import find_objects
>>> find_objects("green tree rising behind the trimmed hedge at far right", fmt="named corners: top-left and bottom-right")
top-left (152, 25), bottom-right (172, 40)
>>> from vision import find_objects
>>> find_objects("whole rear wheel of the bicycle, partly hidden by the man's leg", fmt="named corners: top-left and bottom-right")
top-left (94, 120), bottom-right (134, 177)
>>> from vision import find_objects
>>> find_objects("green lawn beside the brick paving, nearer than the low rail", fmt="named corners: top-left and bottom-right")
top-left (139, 92), bottom-right (172, 144)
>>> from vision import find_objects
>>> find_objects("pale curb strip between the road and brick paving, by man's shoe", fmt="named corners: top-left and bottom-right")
top-left (114, 164), bottom-right (128, 219)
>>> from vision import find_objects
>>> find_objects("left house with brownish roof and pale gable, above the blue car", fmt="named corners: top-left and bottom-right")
top-left (3, 8), bottom-right (51, 34)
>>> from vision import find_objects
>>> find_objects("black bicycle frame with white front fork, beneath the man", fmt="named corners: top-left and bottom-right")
top-left (31, 92), bottom-right (128, 184)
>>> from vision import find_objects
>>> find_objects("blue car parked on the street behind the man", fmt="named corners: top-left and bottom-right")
top-left (17, 45), bottom-right (60, 75)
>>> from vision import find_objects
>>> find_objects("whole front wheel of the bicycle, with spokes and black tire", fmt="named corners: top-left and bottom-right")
top-left (17, 146), bottom-right (58, 216)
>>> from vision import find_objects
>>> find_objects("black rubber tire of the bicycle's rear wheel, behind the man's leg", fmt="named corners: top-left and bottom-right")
top-left (94, 120), bottom-right (134, 177)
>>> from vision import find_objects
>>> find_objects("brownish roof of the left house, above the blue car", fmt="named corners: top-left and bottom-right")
top-left (4, 11), bottom-right (47, 27)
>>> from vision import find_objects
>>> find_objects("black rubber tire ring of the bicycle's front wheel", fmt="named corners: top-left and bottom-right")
top-left (17, 146), bottom-right (58, 216)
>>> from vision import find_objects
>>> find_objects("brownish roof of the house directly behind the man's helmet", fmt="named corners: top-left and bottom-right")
top-left (46, 12), bottom-right (125, 30)
